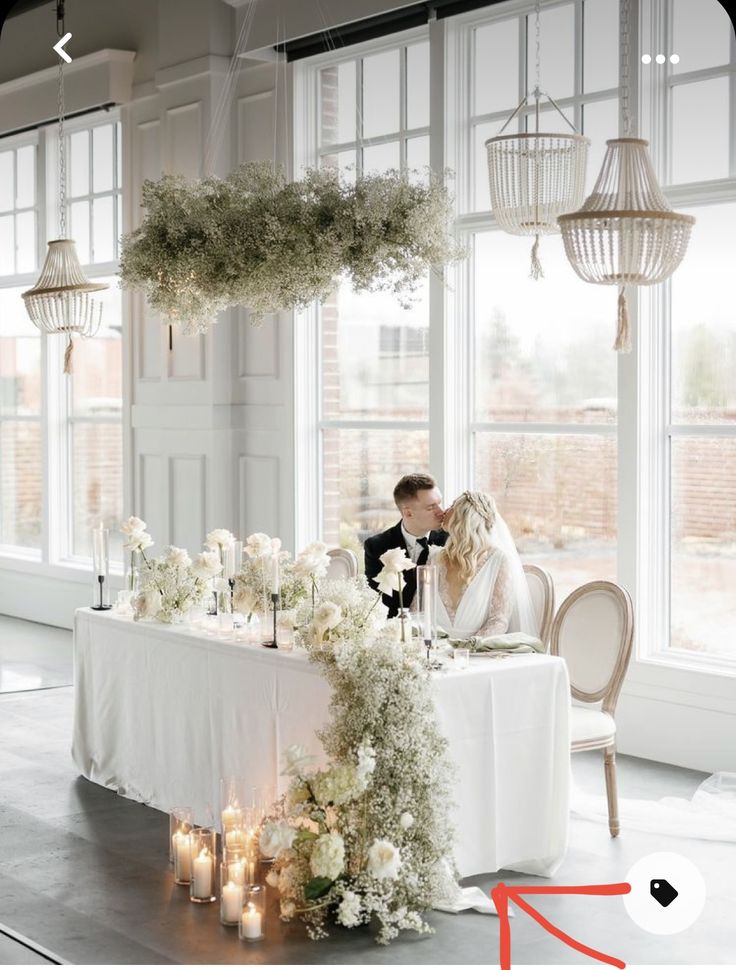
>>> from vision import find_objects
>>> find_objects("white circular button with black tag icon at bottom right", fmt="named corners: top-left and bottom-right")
top-left (623, 852), bottom-right (705, 936)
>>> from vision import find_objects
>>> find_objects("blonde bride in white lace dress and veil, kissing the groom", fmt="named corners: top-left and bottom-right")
top-left (416, 492), bottom-right (538, 640)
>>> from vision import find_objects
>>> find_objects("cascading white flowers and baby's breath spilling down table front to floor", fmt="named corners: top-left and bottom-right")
top-left (261, 635), bottom-right (456, 943)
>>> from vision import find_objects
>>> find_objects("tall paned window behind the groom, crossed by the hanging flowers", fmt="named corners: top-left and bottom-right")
top-left (316, 38), bottom-right (429, 554)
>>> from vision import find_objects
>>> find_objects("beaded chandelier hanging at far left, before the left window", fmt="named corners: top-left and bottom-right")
top-left (23, 3), bottom-right (107, 374)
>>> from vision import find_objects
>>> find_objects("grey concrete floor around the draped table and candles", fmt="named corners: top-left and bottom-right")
top-left (0, 612), bottom-right (736, 965)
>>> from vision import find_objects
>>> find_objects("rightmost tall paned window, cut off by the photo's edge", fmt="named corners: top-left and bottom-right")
top-left (652, 0), bottom-right (736, 661)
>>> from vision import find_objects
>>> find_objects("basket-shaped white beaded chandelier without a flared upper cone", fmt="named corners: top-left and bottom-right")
top-left (485, 0), bottom-right (590, 280)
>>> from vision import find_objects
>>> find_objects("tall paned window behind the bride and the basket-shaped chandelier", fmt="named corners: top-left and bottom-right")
top-left (468, 0), bottom-right (618, 598)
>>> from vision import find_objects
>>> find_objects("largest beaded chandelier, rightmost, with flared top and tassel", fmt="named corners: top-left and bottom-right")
top-left (558, 0), bottom-right (695, 353)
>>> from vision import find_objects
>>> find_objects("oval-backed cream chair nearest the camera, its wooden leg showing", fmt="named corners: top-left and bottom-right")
top-left (550, 580), bottom-right (634, 838)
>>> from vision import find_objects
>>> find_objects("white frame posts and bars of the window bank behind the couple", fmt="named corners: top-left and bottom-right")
top-left (293, 0), bottom-right (736, 714)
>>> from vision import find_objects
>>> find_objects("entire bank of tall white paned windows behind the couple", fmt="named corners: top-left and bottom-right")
top-left (296, 0), bottom-right (736, 670)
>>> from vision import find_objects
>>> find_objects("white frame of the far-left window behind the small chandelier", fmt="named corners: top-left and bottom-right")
top-left (0, 108), bottom-right (128, 580)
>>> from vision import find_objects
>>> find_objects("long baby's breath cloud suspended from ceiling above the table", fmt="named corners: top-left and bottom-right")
top-left (121, 162), bottom-right (464, 334)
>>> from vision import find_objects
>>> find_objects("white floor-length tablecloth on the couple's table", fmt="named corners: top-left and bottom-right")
top-left (72, 609), bottom-right (570, 876)
